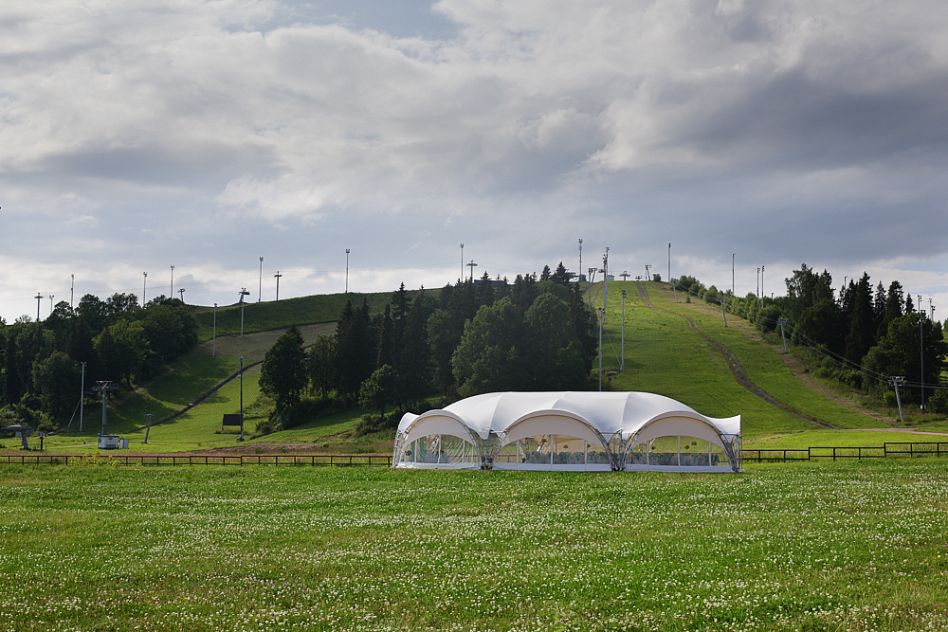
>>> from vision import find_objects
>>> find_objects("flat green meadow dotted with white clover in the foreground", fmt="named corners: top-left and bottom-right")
top-left (0, 460), bottom-right (948, 632)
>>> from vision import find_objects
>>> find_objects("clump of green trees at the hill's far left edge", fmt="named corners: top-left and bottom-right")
top-left (0, 293), bottom-right (197, 430)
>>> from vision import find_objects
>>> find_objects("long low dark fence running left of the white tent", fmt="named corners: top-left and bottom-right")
top-left (0, 453), bottom-right (392, 467)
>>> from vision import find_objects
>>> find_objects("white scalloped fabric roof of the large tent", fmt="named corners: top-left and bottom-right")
top-left (398, 391), bottom-right (741, 440)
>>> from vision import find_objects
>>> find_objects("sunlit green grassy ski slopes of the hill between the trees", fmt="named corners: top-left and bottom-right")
top-left (31, 281), bottom-right (948, 452)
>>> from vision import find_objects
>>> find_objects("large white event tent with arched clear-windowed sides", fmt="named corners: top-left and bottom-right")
top-left (392, 391), bottom-right (741, 472)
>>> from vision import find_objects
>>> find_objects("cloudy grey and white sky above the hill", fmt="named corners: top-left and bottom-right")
top-left (0, 0), bottom-right (948, 322)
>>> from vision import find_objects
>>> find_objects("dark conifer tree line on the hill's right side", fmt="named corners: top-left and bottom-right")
top-left (677, 263), bottom-right (948, 413)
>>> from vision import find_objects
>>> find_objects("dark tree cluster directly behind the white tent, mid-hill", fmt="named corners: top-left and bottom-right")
top-left (260, 262), bottom-right (597, 432)
